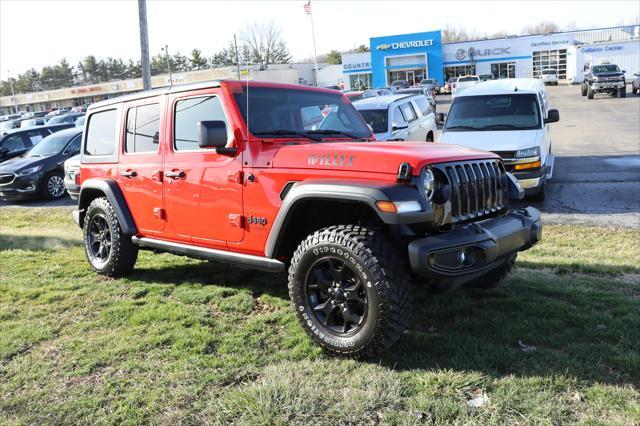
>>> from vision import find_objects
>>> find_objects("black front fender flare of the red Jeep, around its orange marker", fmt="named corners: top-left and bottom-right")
top-left (265, 180), bottom-right (433, 257)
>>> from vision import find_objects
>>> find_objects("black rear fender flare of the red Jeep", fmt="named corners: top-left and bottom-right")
top-left (78, 178), bottom-right (138, 235)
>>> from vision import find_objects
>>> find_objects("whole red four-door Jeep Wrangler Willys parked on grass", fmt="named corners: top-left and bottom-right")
top-left (74, 81), bottom-right (541, 357)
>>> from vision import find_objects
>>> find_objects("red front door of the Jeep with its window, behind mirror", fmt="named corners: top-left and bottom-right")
top-left (164, 90), bottom-right (244, 247)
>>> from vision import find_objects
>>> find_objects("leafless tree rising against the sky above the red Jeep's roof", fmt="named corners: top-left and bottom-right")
top-left (240, 21), bottom-right (291, 65)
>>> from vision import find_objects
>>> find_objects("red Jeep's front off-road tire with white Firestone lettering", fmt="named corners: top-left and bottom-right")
top-left (289, 225), bottom-right (411, 358)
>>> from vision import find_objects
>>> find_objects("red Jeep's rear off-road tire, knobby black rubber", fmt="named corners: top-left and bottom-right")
top-left (82, 197), bottom-right (138, 277)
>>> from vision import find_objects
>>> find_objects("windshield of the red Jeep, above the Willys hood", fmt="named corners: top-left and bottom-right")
top-left (234, 87), bottom-right (371, 139)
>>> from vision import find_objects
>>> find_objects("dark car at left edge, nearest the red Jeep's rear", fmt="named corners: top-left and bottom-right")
top-left (0, 128), bottom-right (82, 200)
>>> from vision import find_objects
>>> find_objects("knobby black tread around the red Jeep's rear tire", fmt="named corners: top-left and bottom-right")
top-left (82, 197), bottom-right (138, 278)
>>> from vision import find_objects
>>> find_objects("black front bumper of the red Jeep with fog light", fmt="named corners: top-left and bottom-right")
top-left (408, 207), bottom-right (542, 289)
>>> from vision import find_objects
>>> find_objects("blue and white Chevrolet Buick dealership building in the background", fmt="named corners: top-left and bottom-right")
top-left (342, 25), bottom-right (640, 90)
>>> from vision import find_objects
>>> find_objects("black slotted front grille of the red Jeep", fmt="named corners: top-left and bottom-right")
top-left (432, 160), bottom-right (506, 223)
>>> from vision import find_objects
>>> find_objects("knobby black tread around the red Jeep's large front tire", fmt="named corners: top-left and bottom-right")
top-left (288, 225), bottom-right (411, 358)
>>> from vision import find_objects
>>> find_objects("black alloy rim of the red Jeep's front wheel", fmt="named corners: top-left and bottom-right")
top-left (306, 256), bottom-right (368, 334)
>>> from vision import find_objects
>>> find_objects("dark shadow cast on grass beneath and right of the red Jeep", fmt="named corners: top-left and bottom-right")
top-left (129, 262), bottom-right (640, 384)
